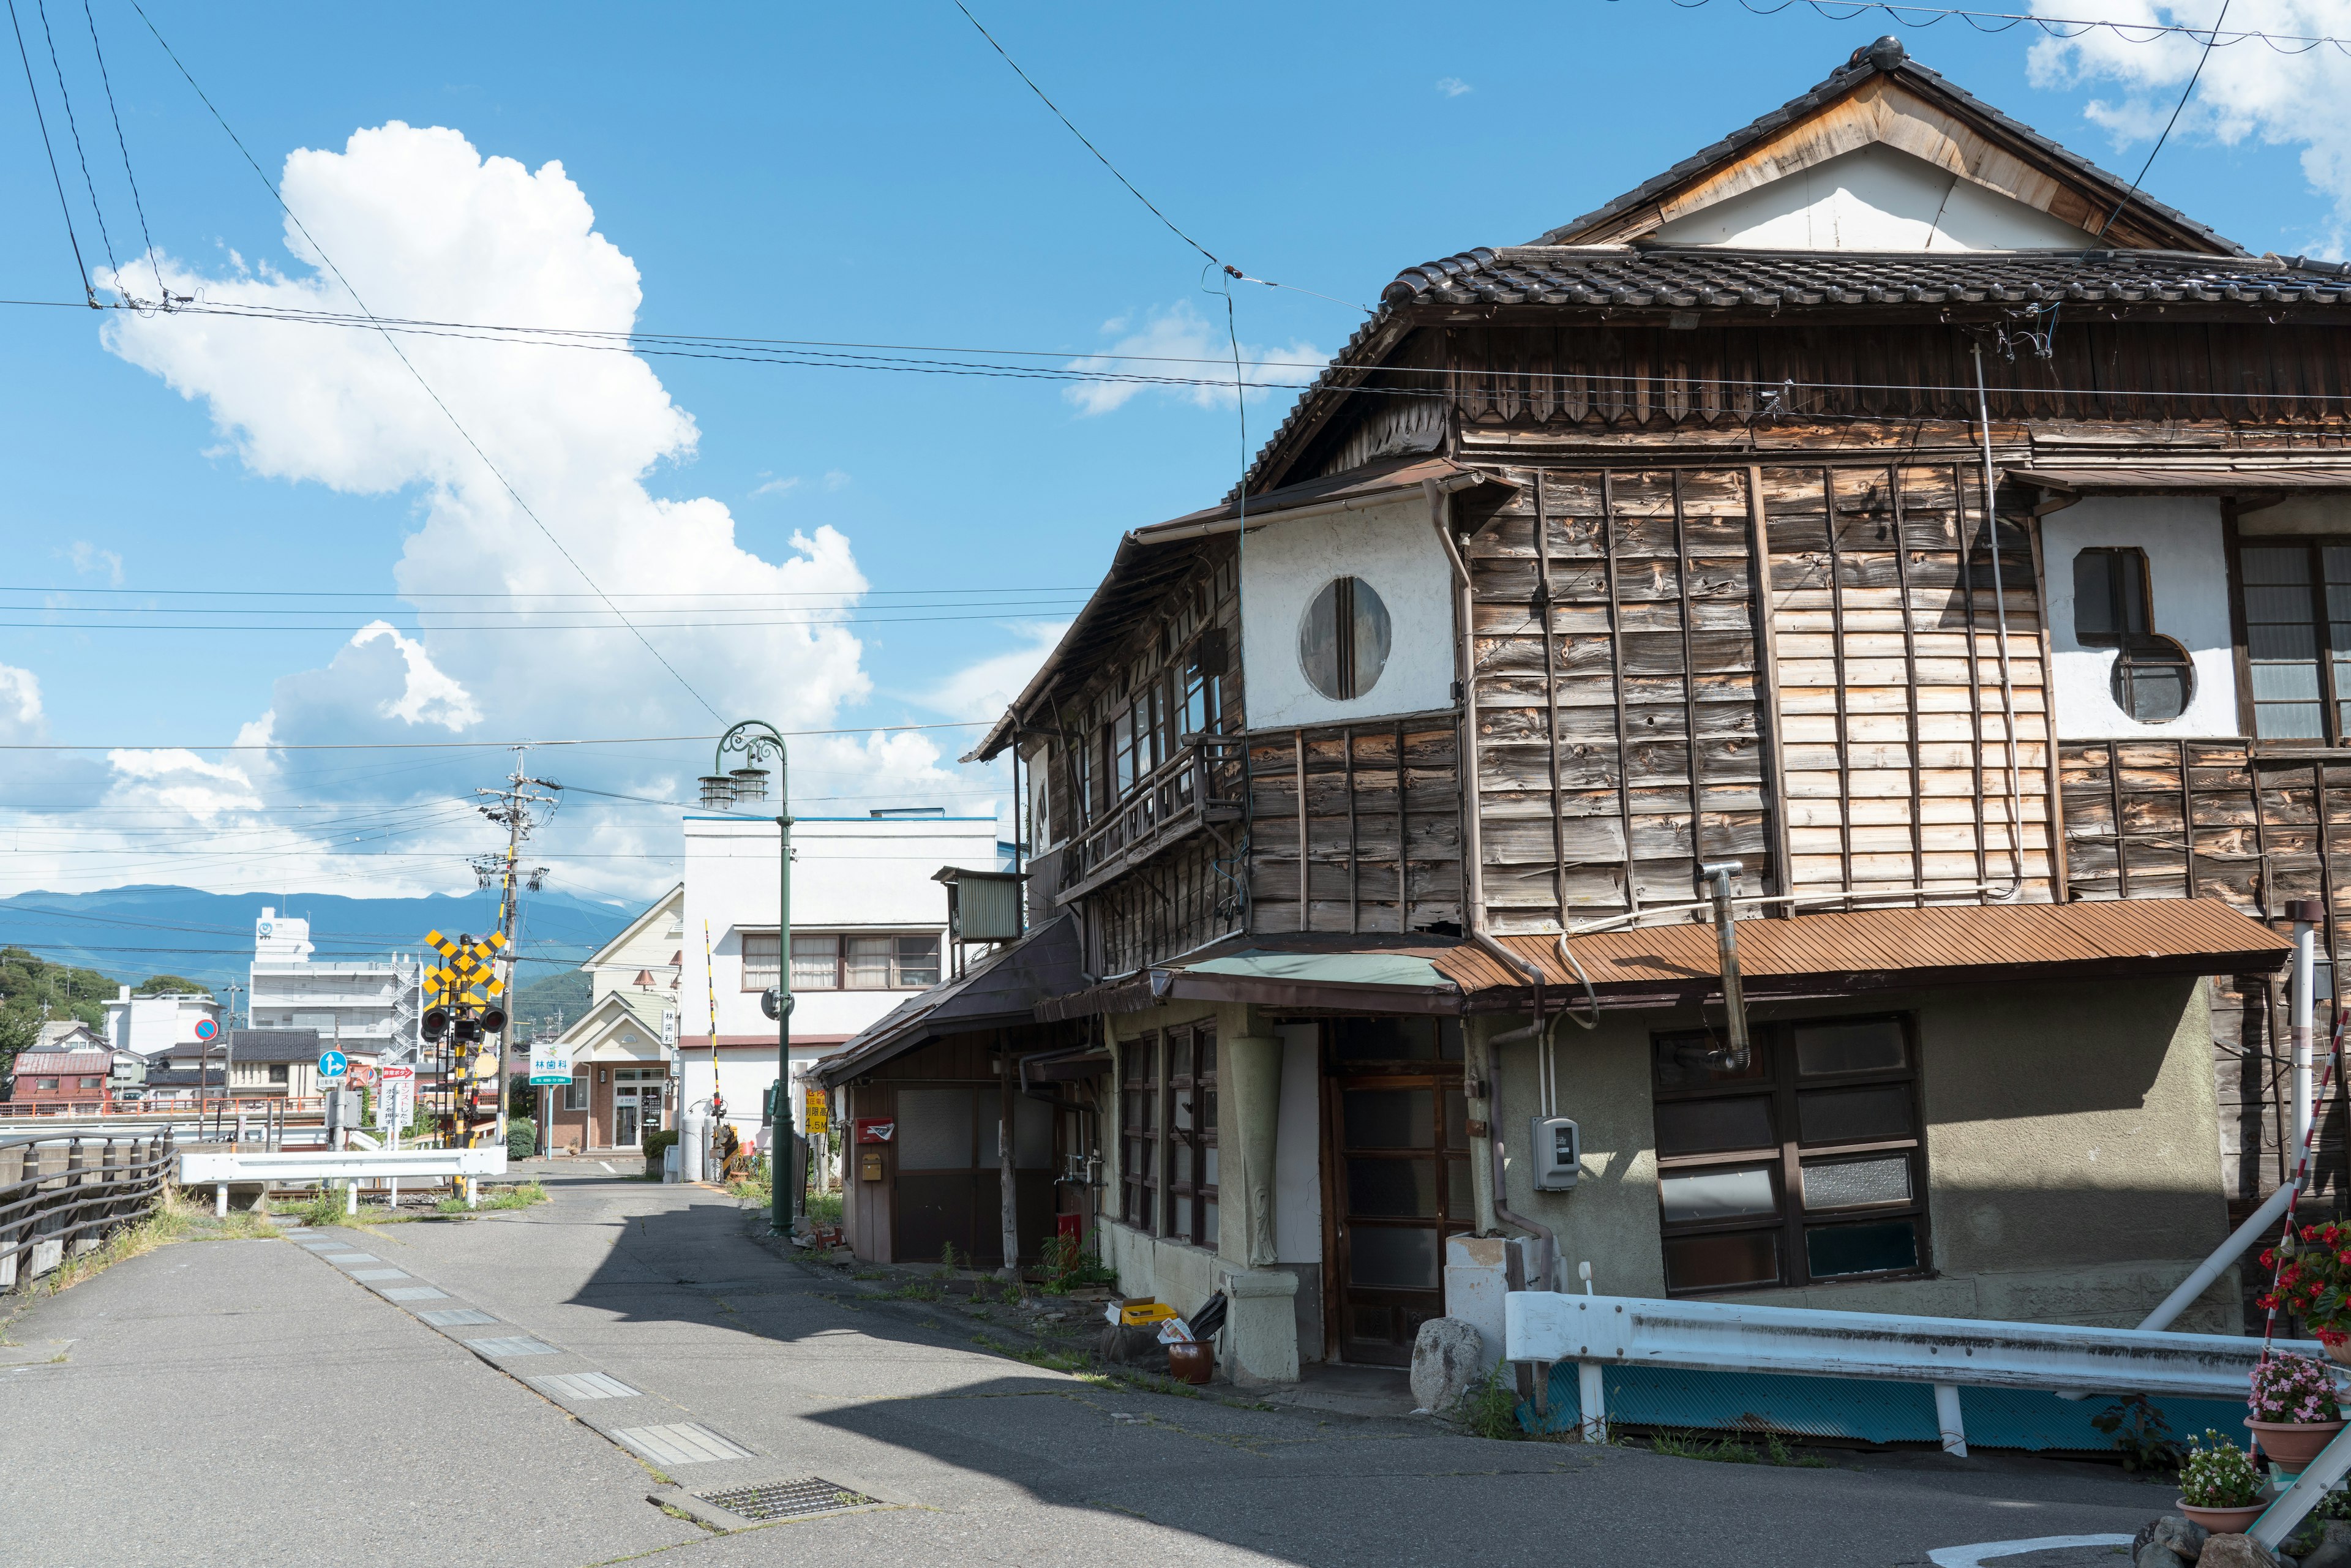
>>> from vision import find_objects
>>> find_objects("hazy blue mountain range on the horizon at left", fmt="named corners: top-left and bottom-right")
top-left (0, 884), bottom-right (642, 989)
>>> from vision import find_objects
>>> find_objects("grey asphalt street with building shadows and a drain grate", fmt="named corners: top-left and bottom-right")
top-left (0, 1168), bottom-right (2170, 1568)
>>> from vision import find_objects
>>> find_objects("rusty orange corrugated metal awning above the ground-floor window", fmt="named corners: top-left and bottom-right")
top-left (1436, 898), bottom-right (2292, 997)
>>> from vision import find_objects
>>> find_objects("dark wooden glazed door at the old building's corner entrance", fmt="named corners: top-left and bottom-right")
top-left (1324, 1020), bottom-right (1477, 1366)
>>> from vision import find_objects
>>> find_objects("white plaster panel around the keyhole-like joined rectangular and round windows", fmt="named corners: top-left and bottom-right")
top-left (2041, 496), bottom-right (2245, 740)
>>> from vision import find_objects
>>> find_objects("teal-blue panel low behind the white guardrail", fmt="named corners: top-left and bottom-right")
top-left (1519, 1361), bottom-right (2248, 1453)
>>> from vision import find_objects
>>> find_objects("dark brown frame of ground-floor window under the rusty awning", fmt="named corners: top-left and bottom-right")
top-left (1648, 1013), bottom-right (1935, 1297)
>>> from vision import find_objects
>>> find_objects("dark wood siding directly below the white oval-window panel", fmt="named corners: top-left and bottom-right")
top-left (1248, 715), bottom-right (1462, 931)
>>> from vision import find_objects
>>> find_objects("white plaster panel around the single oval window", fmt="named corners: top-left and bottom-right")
top-left (1242, 496), bottom-right (1453, 729)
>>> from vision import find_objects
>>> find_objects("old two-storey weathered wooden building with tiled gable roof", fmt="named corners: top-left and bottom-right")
top-left (940, 40), bottom-right (2351, 1378)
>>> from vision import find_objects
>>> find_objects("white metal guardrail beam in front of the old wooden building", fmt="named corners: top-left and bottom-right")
top-left (1502, 1291), bottom-right (2294, 1401)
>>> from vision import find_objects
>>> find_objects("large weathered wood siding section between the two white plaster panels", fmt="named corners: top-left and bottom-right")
top-left (1467, 463), bottom-right (2052, 931)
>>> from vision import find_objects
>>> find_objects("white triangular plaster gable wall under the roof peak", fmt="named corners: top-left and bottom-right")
top-left (1655, 146), bottom-right (2094, 252)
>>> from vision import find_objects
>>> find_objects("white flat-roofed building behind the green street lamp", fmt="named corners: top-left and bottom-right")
top-left (677, 806), bottom-right (1011, 1142)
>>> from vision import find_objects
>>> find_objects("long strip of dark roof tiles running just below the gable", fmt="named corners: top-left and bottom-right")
top-left (1380, 244), bottom-right (2351, 310)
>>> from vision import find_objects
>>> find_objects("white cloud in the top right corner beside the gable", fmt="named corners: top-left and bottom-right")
top-left (2031, 0), bottom-right (2351, 257)
